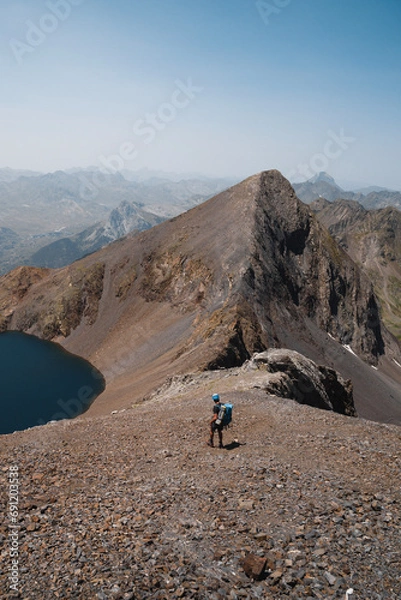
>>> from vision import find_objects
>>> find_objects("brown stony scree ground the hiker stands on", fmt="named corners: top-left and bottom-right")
top-left (0, 370), bottom-right (401, 600)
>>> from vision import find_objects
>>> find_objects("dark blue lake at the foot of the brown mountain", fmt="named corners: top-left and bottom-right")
top-left (0, 331), bottom-right (105, 434)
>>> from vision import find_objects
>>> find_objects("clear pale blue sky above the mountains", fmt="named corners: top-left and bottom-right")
top-left (0, 0), bottom-right (401, 190)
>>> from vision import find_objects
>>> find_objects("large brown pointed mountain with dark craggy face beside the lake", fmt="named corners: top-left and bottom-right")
top-left (0, 171), bottom-right (401, 418)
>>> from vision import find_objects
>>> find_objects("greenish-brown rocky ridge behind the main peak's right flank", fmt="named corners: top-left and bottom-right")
top-left (311, 200), bottom-right (401, 340)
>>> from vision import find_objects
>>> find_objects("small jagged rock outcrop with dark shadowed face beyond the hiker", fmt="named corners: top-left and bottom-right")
top-left (244, 349), bottom-right (356, 417)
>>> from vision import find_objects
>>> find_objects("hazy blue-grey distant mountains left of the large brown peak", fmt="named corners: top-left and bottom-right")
top-left (0, 169), bottom-right (234, 274)
